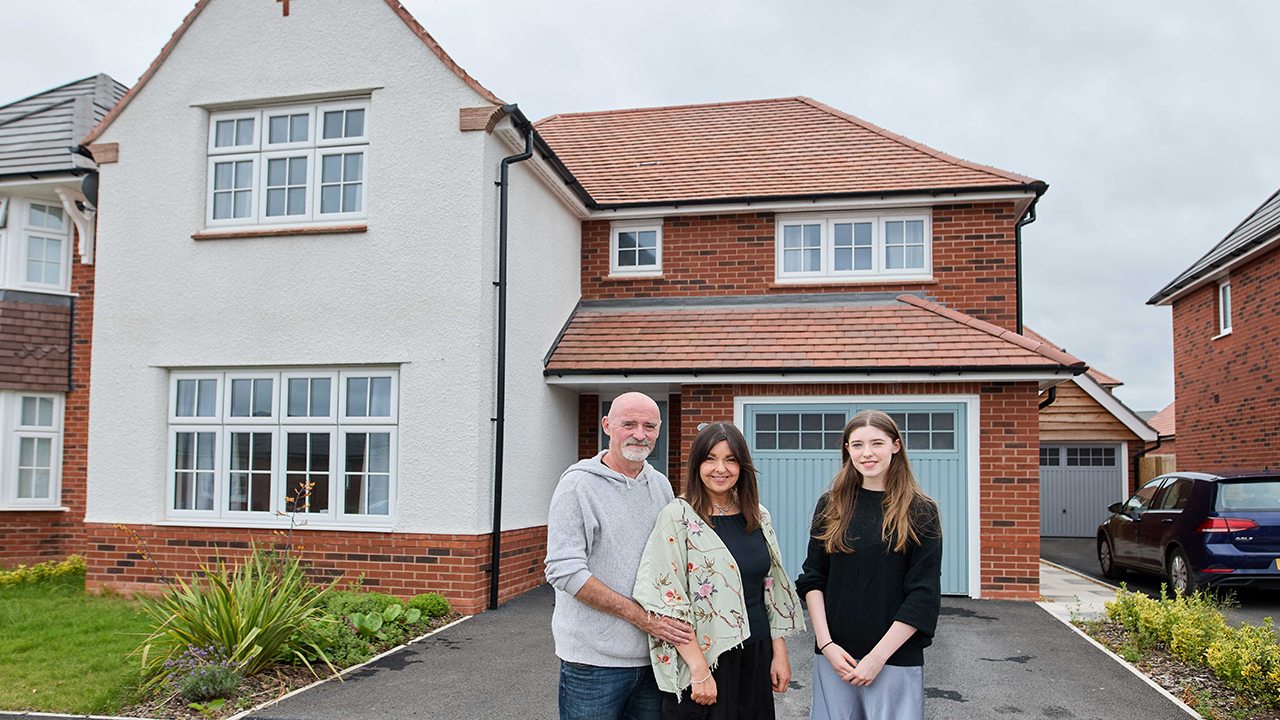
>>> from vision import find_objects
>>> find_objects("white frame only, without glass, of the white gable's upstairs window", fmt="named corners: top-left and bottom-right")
top-left (205, 100), bottom-right (371, 229)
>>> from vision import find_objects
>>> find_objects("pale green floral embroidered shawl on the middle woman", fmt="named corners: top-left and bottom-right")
top-left (632, 497), bottom-right (804, 694)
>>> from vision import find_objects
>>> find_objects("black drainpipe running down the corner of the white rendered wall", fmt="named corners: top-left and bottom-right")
top-left (489, 105), bottom-right (534, 610)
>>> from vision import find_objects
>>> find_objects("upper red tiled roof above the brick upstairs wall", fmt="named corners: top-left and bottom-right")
top-left (536, 97), bottom-right (1047, 206)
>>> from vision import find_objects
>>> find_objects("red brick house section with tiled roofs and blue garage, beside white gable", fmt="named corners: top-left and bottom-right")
top-left (538, 97), bottom-right (1085, 598)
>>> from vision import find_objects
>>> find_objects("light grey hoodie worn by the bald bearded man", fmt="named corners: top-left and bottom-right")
top-left (547, 452), bottom-right (672, 667)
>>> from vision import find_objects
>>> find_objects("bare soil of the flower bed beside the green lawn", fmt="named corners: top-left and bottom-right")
top-left (119, 612), bottom-right (462, 720)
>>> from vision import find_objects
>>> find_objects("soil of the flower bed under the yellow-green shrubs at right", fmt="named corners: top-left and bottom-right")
top-left (1075, 621), bottom-right (1280, 720)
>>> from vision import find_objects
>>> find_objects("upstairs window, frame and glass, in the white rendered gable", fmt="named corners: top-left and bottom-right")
top-left (205, 101), bottom-right (369, 227)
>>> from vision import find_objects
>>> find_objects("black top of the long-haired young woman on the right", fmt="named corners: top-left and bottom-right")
top-left (796, 488), bottom-right (942, 666)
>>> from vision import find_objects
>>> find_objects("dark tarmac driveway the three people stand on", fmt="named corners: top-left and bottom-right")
top-left (251, 585), bottom-right (1187, 720)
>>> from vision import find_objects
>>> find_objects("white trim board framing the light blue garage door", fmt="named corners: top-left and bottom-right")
top-left (733, 395), bottom-right (982, 600)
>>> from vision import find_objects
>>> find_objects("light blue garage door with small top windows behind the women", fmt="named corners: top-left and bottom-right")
top-left (742, 402), bottom-right (969, 594)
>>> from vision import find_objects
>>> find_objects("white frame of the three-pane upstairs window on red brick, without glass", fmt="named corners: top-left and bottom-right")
top-left (773, 209), bottom-right (933, 283)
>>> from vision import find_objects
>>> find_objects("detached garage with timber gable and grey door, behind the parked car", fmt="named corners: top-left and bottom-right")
top-left (1023, 328), bottom-right (1157, 538)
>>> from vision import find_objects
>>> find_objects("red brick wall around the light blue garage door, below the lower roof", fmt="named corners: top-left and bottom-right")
top-left (581, 382), bottom-right (1039, 600)
